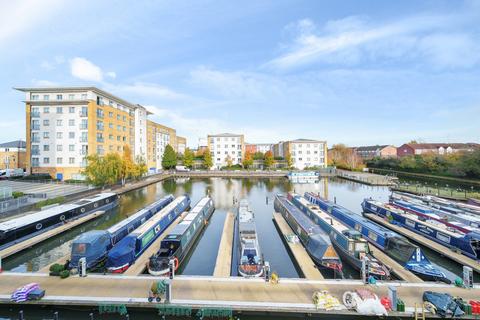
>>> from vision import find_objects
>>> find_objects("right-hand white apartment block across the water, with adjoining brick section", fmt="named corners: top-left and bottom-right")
top-left (273, 139), bottom-right (327, 170)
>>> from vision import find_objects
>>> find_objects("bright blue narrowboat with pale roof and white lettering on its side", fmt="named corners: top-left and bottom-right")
top-left (105, 195), bottom-right (190, 273)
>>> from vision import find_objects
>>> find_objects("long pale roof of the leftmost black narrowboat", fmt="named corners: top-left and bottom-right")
top-left (0, 192), bottom-right (115, 232)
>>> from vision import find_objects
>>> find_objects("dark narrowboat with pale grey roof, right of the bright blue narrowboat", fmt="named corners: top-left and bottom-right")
top-left (147, 196), bottom-right (215, 276)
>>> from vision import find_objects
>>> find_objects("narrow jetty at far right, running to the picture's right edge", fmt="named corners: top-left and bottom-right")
top-left (365, 213), bottom-right (480, 273)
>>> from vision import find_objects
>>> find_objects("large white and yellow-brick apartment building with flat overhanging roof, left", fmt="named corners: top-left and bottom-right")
top-left (17, 87), bottom-right (182, 180)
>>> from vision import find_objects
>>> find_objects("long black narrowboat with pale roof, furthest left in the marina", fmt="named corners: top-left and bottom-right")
top-left (0, 193), bottom-right (118, 249)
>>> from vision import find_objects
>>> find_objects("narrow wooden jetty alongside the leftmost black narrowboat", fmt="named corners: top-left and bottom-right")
top-left (0, 210), bottom-right (105, 259)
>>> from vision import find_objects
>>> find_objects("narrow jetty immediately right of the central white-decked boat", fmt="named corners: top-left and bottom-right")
top-left (273, 212), bottom-right (324, 280)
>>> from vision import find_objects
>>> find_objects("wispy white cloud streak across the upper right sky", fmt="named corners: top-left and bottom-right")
top-left (266, 12), bottom-right (480, 70)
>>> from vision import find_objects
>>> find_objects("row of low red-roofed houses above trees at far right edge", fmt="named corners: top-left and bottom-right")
top-left (397, 143), bottom-right (480, 157)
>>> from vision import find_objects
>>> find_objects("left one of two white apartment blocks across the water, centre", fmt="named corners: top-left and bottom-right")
top-left (207, 133), bottom-right (245, 169)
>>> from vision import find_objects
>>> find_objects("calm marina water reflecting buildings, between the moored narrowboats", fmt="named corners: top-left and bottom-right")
top-left (3, 178), bottom-right (462, 279)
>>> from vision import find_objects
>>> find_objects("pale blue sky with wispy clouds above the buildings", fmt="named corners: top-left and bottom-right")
top-left (0, 0), bottom-right (480, 147)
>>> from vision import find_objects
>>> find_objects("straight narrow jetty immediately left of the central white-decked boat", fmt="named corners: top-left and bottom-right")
top-left (213, 212), bottom-right (235, 278)
